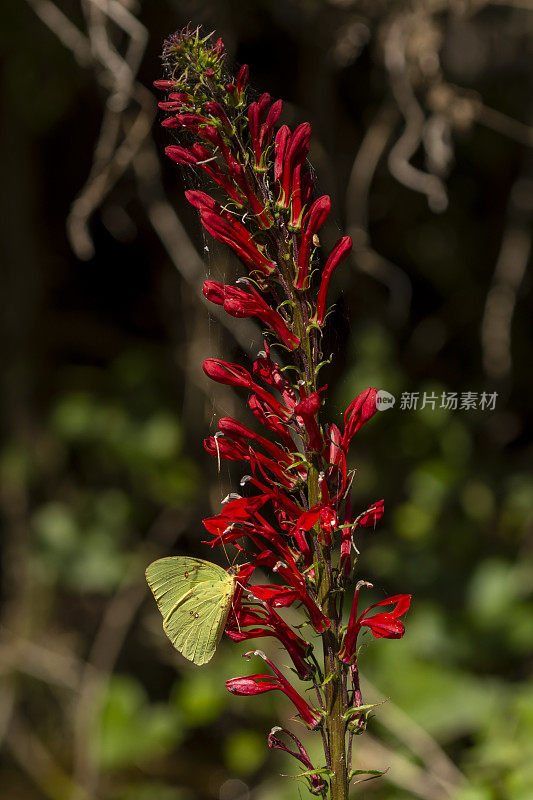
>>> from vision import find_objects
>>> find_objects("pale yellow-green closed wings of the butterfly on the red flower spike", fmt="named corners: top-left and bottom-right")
top-left (146, 556), bottom-right (235, 665)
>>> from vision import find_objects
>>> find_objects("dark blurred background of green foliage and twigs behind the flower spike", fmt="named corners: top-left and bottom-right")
top-left (0, 0), bottom-right (533, 800)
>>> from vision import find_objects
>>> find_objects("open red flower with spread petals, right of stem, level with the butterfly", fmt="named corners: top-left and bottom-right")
top-left (339, 581), bottom-right (411, 664)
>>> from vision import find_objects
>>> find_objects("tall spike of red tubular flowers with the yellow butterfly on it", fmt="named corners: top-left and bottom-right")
top-left (150, 28), bottom-right (411, 800)
